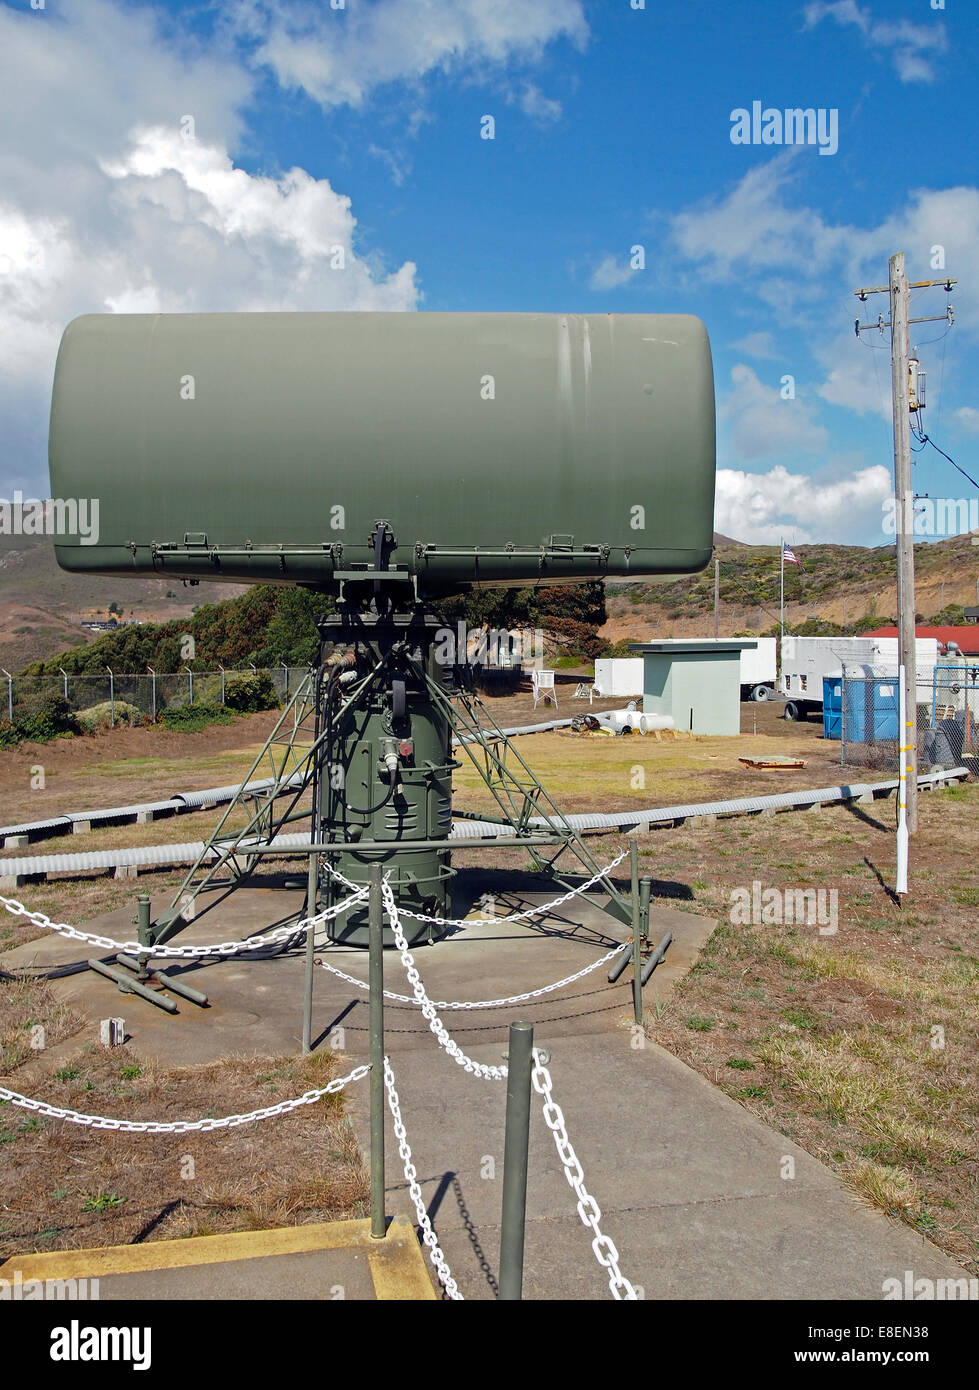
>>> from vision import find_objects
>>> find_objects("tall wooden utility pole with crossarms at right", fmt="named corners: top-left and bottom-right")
top-left (854, 252), bottom-right (955, 835)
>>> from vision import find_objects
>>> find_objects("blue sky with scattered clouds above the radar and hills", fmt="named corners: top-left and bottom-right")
top-left (0, 0), bottom-right (979, 545)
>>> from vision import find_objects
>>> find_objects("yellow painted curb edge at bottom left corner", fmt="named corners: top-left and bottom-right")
top-left (0, 1216), bottom-right (435, 1300)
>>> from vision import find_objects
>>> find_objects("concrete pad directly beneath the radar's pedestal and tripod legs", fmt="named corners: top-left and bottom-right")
top-left (4, 870), bottom-right (713, 1065)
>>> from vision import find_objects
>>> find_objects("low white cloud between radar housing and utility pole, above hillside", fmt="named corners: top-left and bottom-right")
top-left (713, 464), bottom-right (893, 545)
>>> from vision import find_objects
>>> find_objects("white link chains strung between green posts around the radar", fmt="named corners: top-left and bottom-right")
top-left (0, 853), bottom-right (640, 1301)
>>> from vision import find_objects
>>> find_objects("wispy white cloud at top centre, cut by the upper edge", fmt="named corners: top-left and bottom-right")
top-left (229, 0), bottom-right (588, 114)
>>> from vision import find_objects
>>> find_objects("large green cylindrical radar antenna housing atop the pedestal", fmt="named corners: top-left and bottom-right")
top-left (50, 313), bottom-right (715, 595)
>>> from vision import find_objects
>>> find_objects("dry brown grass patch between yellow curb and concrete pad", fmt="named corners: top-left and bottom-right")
top-left (0, 981), bottom-right (369, 1257)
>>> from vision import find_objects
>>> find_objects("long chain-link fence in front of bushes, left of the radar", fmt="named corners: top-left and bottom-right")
top-left (0, 666), bottom-right (309, 723)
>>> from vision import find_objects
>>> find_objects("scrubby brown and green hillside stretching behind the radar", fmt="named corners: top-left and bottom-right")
top-left (9, 534), bottom-right (979, 671)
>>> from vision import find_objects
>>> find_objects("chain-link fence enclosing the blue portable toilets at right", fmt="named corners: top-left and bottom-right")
top-left (825, 657), bottom-right (979, 773)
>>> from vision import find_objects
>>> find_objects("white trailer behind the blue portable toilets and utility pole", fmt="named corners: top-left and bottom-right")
top-left (779, 637), bottom-right (939, 719)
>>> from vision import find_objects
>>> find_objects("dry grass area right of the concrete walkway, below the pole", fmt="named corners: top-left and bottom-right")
top-left (647, 785), bottom-right (979, 1272)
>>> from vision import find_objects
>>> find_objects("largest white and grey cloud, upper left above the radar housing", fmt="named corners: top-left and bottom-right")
top-left (0, 0), bottom-right (428, 493)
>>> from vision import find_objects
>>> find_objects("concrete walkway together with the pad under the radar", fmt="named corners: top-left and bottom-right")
top-left (6, 870), bottom-right (962, 1300)
